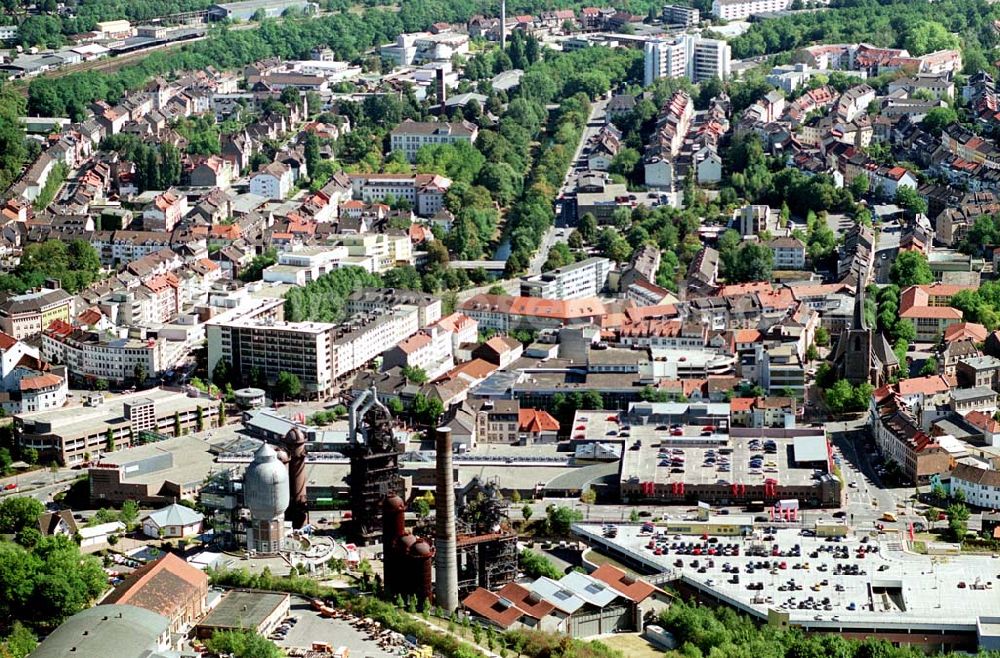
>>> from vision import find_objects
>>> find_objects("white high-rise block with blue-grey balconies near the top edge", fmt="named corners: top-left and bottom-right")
top-left (643, 34), bottom-right (732, 85)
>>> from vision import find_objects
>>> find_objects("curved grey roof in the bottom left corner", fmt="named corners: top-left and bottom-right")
top-left (31, 605), bottom-right (170, 658)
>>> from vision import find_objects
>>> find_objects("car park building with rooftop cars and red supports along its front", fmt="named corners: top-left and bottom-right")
top-left (571, 402), bottom-right (842, 507)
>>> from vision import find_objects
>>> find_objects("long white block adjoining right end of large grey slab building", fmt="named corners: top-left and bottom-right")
top-left (332, 305), bottom-right (420, 378)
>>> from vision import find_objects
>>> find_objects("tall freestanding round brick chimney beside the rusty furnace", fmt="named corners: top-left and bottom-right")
top-left (434, 427), bottom-right (458, 612)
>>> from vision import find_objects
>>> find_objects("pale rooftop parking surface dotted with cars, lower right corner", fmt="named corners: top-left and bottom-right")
top-left (578, 525), bottom-right (1000, 632)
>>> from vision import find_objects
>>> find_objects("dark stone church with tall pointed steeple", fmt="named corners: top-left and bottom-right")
top-left (833, 286), bottom-right (900, 388)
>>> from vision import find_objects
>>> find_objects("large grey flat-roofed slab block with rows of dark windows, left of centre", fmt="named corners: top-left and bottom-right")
top-left (206, 299), bottom-right (337, 396)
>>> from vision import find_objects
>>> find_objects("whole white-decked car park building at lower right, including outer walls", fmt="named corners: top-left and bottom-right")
top-left (574, 517), bottom-right (1000, 651)
